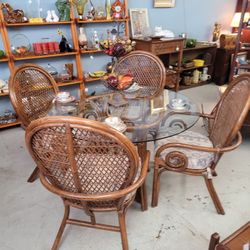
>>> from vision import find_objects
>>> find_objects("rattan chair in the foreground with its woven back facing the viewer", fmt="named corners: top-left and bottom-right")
top-left (26, 116), bottom-right (149, 249)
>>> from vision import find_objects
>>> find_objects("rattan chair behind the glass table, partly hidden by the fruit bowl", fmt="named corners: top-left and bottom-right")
top-left (113, 50), bottom-right (166, 98)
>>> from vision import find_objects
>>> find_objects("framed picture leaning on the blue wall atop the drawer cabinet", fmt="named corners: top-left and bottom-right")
top-left (129, 8), bottom-right (149, 38)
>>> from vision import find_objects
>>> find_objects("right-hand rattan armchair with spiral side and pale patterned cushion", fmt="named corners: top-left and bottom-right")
top-left (152, 73), bottom-right (250, 214)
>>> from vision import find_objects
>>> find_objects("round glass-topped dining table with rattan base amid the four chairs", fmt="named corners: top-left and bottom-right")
top-left (48, 90), bottom-right (199, 210)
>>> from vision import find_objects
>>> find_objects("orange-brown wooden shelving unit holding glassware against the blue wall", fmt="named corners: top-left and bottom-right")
top-left (0, 0), bottom-right (129, 129)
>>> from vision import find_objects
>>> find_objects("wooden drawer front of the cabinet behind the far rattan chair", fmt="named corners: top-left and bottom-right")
top-left (152, 41), bottom-right (183, 55)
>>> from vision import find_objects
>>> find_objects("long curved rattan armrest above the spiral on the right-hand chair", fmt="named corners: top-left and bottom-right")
top-left (155, 132), bottom-right (242, 157)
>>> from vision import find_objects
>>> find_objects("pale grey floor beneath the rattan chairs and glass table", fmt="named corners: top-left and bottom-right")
top-left (0, 85), bottom-right (250, 250)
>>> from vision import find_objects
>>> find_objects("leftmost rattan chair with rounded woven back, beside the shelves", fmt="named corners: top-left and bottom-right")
top-left (9, 64), bottom-right (58, 182)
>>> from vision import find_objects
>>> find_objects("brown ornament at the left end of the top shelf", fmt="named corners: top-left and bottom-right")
top-left (1, 3), bottom-right (28, 23)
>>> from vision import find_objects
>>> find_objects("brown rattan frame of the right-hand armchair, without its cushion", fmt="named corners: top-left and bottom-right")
top-left (152, 73), bottom-right (250, 214)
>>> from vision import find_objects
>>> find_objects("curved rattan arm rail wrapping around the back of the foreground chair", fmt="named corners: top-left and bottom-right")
top-left (40, 151), bottom-right (149, 201)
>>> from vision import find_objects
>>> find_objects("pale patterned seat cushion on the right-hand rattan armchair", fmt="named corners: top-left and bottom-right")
top-left (156, 131), bottom-right (214, 169)
